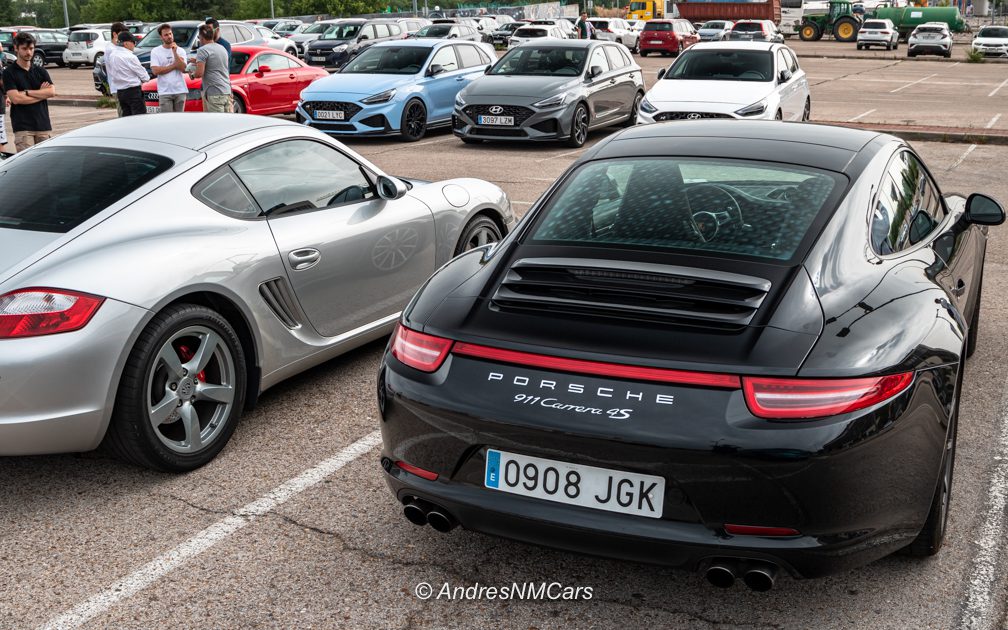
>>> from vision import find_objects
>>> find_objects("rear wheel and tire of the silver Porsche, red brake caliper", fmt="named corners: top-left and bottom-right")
top-left (104, 304), bottom-right (246, 473)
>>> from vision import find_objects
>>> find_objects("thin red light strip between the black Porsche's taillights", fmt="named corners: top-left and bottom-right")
top-left (452, 342), bottom-right (742, 389)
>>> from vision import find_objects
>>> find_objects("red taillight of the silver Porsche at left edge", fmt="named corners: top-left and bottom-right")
top-left (0, 288), bottom-right (105, 339)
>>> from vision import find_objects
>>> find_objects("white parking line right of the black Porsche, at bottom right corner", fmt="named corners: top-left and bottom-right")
top-left (960, 383), bottom-right (1008, 630)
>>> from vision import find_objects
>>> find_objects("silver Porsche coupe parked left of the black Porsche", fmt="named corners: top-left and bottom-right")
top-left (0, 113), bottom-right (514, 471)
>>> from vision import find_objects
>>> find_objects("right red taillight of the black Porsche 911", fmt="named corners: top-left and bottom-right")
top-left (742, 372), bottom-right (913, 418)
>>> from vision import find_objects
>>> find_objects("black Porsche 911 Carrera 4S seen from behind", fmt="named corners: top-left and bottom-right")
top-left (378, 121), bottom-right (1005, 590)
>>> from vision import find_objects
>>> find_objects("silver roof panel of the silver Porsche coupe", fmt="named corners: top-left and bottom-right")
top-left (52, 112), bottom-right (301, 151)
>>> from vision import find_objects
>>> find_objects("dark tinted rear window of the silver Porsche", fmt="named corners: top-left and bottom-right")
top-left (0, 146), bottom-right (172, 233)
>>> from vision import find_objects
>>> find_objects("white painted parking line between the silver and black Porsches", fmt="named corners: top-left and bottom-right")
top-left (41, 431), bottom-right (381, 630)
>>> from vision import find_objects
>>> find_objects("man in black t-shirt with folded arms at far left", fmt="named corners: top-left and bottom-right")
top-left (3, 31), bottom-right (56, 151)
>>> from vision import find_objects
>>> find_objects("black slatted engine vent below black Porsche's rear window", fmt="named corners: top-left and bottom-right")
top-left (493, 258), bottom-right (770, 330)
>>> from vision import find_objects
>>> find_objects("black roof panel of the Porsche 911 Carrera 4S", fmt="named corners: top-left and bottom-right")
top-left (579, 120), bottom-right (896, 172)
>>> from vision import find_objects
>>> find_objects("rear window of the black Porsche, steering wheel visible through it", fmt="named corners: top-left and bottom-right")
top-left (530, 158), bottom-right (843, 260)
